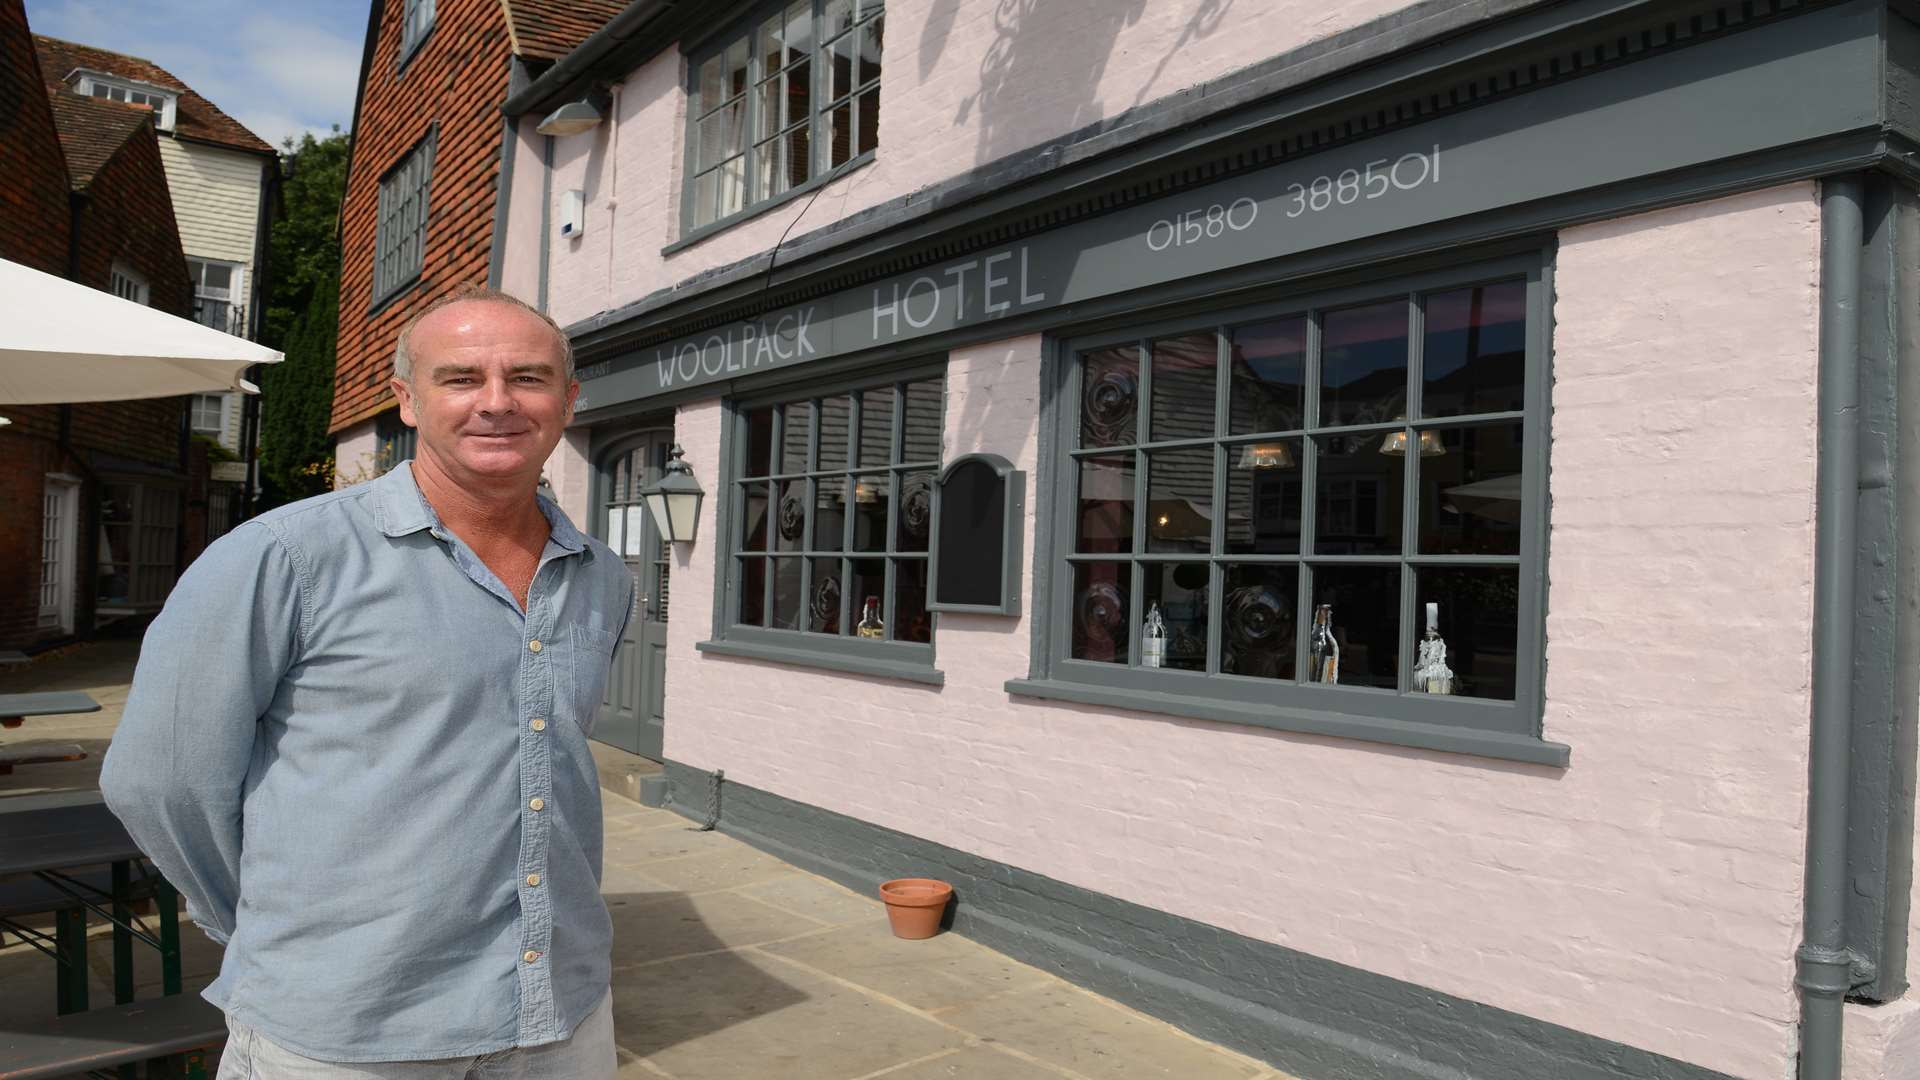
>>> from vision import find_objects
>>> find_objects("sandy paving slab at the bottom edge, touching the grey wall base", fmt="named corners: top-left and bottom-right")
top-left (925, 980), bottom-right (1267, 1080)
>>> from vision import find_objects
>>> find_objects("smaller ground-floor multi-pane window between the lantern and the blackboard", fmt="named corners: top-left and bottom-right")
top-left (718, 369), bottom-right (945, 669)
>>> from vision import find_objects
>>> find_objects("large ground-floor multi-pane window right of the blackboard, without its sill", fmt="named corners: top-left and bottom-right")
top-left (1039, 259), bottom-right (1546, 736)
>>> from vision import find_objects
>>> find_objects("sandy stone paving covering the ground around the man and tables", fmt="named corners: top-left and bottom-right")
top-left (0, 642), bottom-right (1284, 1080)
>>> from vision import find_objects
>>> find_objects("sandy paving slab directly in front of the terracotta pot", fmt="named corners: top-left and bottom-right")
top-left (766, 913), bottom-right (1052, 1019)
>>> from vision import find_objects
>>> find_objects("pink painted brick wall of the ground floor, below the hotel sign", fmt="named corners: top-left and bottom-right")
top-left (666, 184), bottom-right (1818, 1080)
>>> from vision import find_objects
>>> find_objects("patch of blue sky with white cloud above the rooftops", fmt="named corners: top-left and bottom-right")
top-left (27, 0), bottom-right (369, 146)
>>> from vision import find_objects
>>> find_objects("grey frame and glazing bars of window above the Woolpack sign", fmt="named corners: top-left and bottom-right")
top-left (664, 0), bottom-right (887, 239)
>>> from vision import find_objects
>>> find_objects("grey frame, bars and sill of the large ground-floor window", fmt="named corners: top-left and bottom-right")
top-left (1008, 254), bottom-right (1567, 765)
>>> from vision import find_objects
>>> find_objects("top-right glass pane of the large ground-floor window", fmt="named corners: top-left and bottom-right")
top-left (1421, 281), bottom-right (1526, 417)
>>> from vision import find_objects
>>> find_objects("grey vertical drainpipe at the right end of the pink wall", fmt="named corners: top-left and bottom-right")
top-left (1793, 175), bottom-right (1864, 1080)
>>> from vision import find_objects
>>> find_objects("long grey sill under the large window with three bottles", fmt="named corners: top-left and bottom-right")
top-left (1006, 678), bottom-right (1572, 769)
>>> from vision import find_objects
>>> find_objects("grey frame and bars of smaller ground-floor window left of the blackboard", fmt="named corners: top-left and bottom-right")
top-left (697, 359), bottom-right (948, 686)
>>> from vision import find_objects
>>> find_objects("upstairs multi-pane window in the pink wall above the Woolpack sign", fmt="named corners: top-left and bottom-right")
top-left (685, 0), bottom-right (885, 229)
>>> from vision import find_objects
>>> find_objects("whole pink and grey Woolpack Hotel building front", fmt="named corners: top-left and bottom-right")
top-left (503, 0), bottom-right (1920, 1080)
